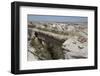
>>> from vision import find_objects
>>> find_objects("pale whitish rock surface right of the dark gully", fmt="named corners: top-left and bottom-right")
top-left (62, 37), bottom-right (88, 59)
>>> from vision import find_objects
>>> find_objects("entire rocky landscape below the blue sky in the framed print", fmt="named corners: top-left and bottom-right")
top-left (27, 22), bottom-right (88, 61)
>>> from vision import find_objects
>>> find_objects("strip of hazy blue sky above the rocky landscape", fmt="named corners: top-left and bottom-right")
top-left (28, 15), bottom-right (88, 22)
